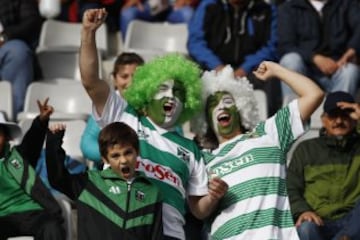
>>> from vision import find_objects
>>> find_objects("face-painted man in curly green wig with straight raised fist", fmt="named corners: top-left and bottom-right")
top-left (80, 9), bottom-right (227, 240)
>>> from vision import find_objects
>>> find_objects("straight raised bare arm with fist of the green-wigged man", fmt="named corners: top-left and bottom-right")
top-left (79, 9), bottom-right (110, 115)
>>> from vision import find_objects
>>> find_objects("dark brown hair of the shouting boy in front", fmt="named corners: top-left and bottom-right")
top-left (98, 122), bottom-right (139, 157)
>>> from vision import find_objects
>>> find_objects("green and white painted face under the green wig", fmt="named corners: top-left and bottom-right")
top-left (146, 79), bottom-right (185, 129)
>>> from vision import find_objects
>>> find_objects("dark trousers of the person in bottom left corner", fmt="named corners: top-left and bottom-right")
top-left (0, 210), bottom-right (66, 240)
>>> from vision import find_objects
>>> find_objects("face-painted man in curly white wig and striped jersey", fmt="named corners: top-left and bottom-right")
top-left (198, 61), bottom-right (324, 240)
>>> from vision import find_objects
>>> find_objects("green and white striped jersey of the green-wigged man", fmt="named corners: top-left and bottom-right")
top-left (93, 91), bottom-right (208, 239)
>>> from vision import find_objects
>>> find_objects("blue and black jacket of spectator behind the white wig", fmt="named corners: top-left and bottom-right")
top-left (188, 0), bottom-right (277, 73)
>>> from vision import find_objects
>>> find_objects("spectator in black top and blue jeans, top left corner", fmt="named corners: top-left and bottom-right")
top-left (0, 0), bottom-right (42, 119)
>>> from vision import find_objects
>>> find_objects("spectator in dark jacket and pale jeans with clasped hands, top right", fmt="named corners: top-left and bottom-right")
top-left (279, 0), bottom-right (360, 105)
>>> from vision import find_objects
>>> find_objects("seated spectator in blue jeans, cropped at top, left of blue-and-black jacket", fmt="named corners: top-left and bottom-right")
top-left (119, 0), bottom-right (198, 40)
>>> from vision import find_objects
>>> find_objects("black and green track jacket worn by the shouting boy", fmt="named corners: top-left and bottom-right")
top-left (46, 132), bottom-right (163, 240)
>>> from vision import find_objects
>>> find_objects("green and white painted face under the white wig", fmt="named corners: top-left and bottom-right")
top-left (207, 92), bottom-right (241, 138)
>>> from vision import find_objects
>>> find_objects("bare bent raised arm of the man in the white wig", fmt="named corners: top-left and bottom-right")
top-left (254, 61), bottom-right (324, 121)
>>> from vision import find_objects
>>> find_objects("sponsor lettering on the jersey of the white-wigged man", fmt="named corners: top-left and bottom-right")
top-left (211, 154), bottom-right (254, 177)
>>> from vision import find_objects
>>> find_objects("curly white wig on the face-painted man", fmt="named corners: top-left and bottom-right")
top-left (196, 65), bottom-right (259, 134)
